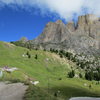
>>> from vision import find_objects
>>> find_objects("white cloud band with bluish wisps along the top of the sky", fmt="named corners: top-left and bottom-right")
top-left (0, 0), bottom-right (100, 20)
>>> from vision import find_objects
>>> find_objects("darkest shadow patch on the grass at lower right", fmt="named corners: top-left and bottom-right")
top-left (51, 86), bottom-right (100, 100)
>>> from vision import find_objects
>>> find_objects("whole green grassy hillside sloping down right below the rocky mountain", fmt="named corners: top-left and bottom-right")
top-left (0, 42), bottom-right (100, 100)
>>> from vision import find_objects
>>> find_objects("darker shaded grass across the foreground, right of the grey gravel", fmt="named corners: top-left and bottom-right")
top-left (24, 86), bottom-right (100, 100)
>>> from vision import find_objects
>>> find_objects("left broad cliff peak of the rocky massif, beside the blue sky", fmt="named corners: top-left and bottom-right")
top-left (35, 20), bottom-right (70, 43)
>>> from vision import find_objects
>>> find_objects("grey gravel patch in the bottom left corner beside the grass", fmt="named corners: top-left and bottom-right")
top-left (0, 82), bottom-right (28, 100)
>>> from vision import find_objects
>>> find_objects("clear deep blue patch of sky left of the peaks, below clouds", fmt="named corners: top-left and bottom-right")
top-left (0, 7), bottom-right (55, 41)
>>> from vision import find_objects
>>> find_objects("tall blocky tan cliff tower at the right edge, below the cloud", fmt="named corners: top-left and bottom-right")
top-left (77, 15), bottom-right (100, 38)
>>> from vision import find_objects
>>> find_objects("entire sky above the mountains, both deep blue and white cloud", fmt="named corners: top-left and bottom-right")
top-left (0, 0), bottom-right (100, 41)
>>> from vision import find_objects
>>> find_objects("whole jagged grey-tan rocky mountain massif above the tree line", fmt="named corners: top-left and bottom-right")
top-left (31, 14), bottom-right (100, 54)
